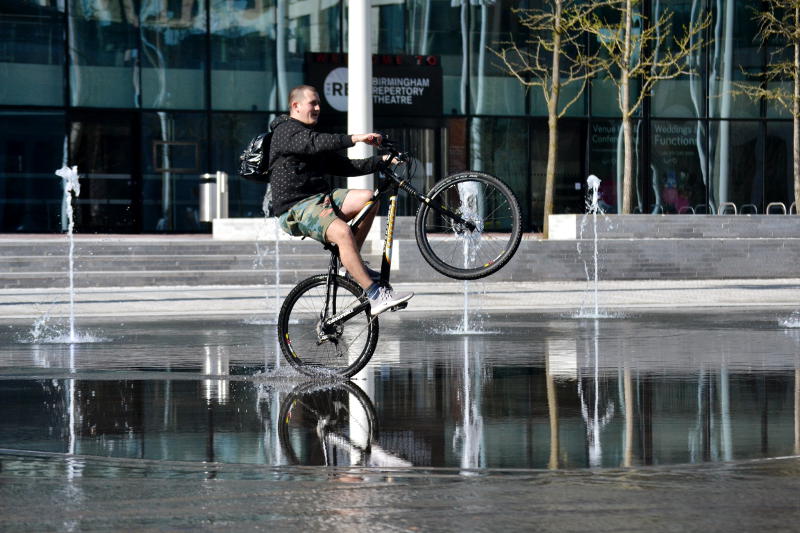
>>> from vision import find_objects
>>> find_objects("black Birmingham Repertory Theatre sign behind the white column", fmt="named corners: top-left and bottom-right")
top-left (306, 53), bottom-right (442, 116)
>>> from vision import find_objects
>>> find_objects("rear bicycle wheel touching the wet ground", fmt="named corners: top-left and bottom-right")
top-left (278, 274), bottom-right (378, 377)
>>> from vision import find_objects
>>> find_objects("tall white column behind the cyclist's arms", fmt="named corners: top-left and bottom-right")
top-left (347, 0), bottom-right (373, 189)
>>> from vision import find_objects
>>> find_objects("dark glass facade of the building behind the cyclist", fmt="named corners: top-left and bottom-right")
top-left (0, 0), bottom-right (793, 233)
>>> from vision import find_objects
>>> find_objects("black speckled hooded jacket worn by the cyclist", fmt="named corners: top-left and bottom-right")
top-left (269, 115), bottom-right (384, 216)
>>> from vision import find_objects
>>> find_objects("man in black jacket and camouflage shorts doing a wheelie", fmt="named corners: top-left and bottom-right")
top-left (269, 85), bottom-right (414, 315)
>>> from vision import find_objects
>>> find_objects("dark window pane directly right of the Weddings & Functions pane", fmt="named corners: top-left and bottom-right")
top-left (710, 120), bottom-right (764, 213)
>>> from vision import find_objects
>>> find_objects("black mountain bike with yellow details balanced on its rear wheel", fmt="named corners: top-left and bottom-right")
top-left (278, 141), bottom-right (522, 378)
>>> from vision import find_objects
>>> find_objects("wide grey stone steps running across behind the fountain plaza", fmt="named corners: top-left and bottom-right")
top-left (0, 230), bottom-right (800, 288)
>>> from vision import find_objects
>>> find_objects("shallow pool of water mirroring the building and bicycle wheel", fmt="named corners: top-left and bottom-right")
top-left (0, 314), bottom-right (800, 474)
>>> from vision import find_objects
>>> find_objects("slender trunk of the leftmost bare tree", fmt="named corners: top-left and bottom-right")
top-left (543, 0), bottom-right (561, 239)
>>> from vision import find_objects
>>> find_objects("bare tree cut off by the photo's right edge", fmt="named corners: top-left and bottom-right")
top-left (732, 0), bottom-right (800, 212)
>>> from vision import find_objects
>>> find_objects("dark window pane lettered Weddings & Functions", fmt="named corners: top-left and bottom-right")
top-left (648, 120), bottom-right (707, 214)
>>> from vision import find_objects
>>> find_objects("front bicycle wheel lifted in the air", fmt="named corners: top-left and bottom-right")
top-left (415, 172), bottom-right (522, 279)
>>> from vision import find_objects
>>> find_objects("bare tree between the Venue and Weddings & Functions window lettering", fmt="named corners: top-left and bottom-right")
top-left (583, 0), bottom-right (711, 213)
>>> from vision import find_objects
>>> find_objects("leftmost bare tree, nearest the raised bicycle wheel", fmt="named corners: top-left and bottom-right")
top-left (491, 0), bottom-right (597, 238)
